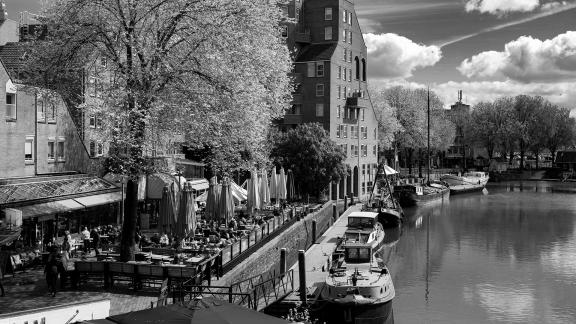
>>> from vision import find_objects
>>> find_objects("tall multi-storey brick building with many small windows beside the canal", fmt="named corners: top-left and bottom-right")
top-left (281, 0), bottom-right (378, 199)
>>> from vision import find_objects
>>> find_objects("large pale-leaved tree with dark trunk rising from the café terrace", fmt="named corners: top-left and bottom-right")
top-left (28, 0), bottom-right (291, 261)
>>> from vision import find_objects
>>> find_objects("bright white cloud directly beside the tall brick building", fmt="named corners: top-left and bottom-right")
top-left (364, 33), bottom-right (442, 79)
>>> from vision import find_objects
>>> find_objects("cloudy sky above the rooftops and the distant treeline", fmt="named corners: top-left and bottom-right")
top-left (4, 0), bottom-right (576, 109)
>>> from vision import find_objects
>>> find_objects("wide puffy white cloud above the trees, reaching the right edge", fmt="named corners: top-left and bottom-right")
top-left (458, 31), bottom-right (576, 82)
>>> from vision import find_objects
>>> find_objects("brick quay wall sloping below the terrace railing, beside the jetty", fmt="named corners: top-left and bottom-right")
top-left (219, 200), bottom-right (344, 285)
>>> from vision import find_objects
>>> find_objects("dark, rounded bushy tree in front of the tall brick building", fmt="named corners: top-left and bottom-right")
top-left (271, 123), bottom-right (347, 197)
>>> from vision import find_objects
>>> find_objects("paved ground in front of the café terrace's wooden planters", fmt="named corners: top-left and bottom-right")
top-left (0, 266), bottom-right (159, 315)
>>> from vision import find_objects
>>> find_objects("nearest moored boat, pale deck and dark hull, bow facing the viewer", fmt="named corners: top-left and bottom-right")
top-left (321, 221), bottom-right (395, 324)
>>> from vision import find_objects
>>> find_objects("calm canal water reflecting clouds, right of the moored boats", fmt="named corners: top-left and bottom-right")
top-left (378, 182), bottom-right (576, 324)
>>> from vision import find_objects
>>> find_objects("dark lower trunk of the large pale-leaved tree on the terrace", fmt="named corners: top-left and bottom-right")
top-left (120, 179), bottom-right (138, 262)
